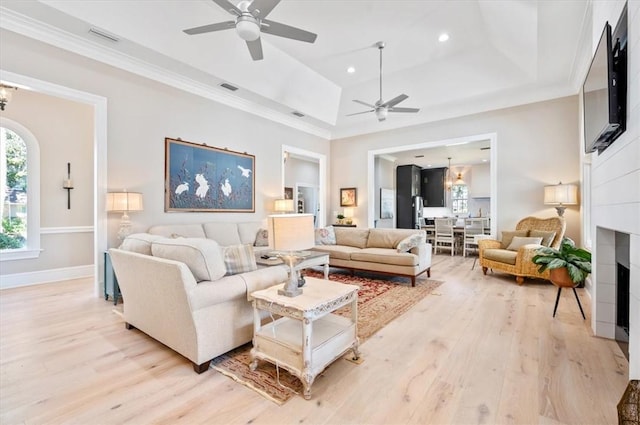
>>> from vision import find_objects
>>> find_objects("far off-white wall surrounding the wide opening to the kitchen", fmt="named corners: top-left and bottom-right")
top-left (329, 96), bottom-right (581, 243)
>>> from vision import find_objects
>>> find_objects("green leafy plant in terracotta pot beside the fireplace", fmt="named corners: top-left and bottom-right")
top-left (531, 238), bottom-right (591, 288)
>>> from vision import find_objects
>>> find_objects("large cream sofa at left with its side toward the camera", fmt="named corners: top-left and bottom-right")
top-left (109, 223), bottom-right (287, 373)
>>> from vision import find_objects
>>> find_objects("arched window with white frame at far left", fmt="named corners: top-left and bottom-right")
top-left (0, 117), bottom-right (40, 261)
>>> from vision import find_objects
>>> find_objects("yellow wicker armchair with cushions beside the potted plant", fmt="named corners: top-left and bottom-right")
top-left (478, 217), bottom-right (567, 285)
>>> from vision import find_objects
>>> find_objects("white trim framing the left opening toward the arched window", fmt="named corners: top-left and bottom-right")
top-left (0, 69), bottom-right (107, 296)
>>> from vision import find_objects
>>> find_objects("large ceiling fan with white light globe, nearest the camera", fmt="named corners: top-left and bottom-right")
top-left (184, 0), bottom-right (317, 61)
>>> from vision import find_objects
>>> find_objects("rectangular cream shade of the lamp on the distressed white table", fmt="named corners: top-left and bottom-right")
top-left (269, 214), bottom-right (315, 251)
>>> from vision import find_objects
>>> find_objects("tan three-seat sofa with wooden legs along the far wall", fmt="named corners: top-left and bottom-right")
top-left (313, 226), bottom-right (431, 286)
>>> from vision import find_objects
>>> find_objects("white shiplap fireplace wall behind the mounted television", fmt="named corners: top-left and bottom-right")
top-left (587, 0), bottom-right (640, 379)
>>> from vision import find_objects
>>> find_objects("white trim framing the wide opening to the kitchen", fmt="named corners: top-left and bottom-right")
top-left (367, 133), bottom-right (498, 237)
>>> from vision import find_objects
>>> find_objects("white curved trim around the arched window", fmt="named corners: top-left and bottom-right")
top-left (0, 117), bottom-right (41, 261)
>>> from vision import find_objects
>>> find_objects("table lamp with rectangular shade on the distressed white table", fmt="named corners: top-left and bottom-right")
top-left (269, 214), bottom-right (315, 297)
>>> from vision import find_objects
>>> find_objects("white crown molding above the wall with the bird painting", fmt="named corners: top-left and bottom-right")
top-left (0, 7), bottom-right (331, 140)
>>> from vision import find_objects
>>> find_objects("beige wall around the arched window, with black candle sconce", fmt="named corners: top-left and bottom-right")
top-left (0, 89), bottom-right (94, 276)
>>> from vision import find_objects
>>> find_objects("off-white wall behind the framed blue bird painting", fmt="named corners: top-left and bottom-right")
top-left (0, 30), bottom-right (330, 282)
